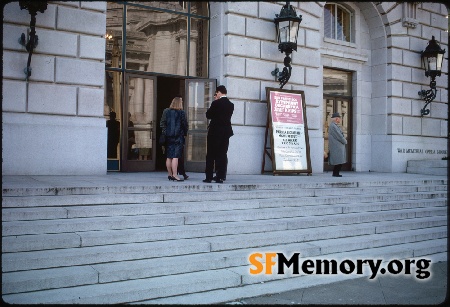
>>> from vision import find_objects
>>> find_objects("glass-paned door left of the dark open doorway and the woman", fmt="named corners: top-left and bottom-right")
top-left (121, 74), bottom-right (157, 172)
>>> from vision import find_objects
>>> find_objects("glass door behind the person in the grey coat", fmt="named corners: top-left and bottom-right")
top-left (323, 96), bottom-right (352, 171)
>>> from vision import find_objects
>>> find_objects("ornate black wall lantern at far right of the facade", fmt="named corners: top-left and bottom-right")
top-left (419, 36), bottom-right (445, 116)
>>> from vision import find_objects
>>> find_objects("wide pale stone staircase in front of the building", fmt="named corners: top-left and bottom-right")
top-left (2, 177), bottom-right (447, 304)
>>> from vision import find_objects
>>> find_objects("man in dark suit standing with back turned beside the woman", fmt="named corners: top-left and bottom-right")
top-left (203, 85), bottom-right (234, 183)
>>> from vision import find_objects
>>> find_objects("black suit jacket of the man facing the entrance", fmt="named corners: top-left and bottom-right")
top-left (206, 97), bottom-right (234, 137)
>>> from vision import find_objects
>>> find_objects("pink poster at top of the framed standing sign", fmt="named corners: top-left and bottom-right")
top-left (270, 92), bottom-right (303, 125)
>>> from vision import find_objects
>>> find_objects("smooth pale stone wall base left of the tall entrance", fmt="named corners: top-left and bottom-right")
top-left (2, 112), bottom-right (107, 175)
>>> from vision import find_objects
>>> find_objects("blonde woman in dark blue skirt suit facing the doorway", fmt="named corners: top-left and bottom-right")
top-left (160, 97), bottom-right (188, 181)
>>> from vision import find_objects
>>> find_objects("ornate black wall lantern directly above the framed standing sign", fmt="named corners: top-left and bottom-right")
top-left (272, 1), bottom-right (302, 88)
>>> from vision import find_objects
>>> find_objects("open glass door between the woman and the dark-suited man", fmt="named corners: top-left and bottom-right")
top-left (184, 79), bottom-right (216, 172)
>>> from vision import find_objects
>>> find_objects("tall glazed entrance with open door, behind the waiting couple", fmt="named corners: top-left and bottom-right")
top-left (104, 1), bottom-right (211, 172)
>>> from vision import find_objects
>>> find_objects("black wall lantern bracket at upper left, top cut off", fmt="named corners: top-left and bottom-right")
top-left (19, 1), bottom-right (47, 80)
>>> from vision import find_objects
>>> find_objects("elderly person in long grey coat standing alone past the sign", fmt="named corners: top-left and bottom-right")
top-left (328, 113), bottom-right (347, 177)
